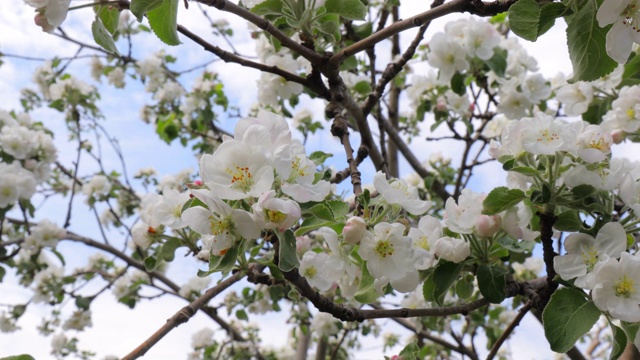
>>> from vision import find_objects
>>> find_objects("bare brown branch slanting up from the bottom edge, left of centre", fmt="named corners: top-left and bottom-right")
top-left (122, 272), bottom-right (245, 360)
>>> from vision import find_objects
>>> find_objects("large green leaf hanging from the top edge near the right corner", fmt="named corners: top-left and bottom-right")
top-left (567, 0), bottom-right (618, 83)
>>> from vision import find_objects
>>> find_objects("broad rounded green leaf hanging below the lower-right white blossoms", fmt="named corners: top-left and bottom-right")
top-left (542, 288), bottom-right (601, 353)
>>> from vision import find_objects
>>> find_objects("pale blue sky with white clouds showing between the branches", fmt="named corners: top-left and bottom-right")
top-left (0, 0), bottom-right (584, 359)
